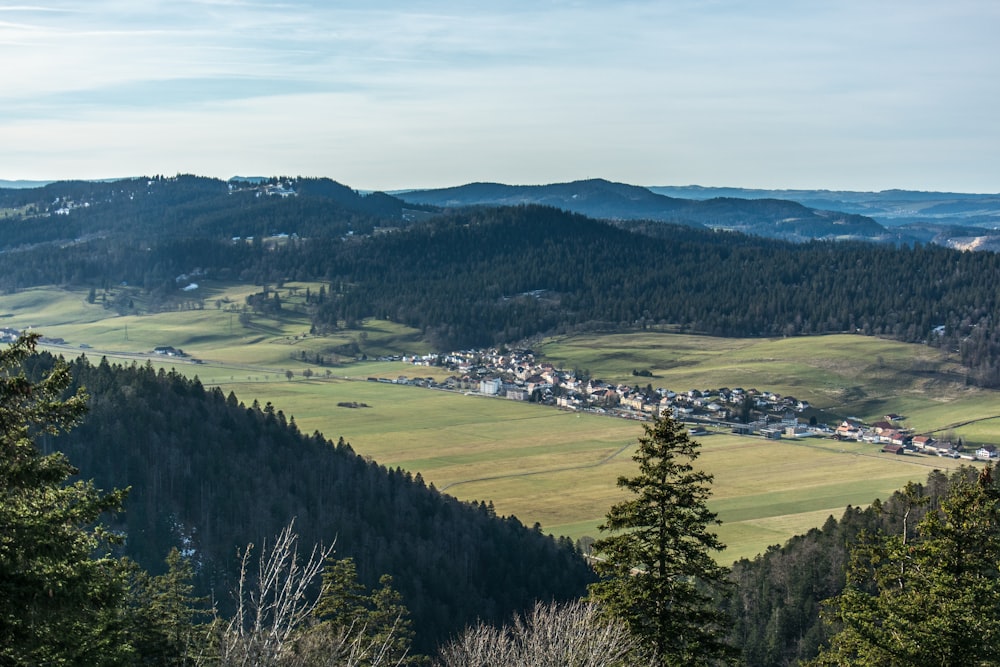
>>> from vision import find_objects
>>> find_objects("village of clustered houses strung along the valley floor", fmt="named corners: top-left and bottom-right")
top-left (368, 349), bottom-right (1000, 460)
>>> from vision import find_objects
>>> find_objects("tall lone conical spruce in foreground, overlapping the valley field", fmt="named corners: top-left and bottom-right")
top-left (590, 415), bottom-right (732, 665)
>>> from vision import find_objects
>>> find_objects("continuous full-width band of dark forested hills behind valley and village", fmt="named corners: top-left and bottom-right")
top-left (0, 177), bottom-right (1000, 387)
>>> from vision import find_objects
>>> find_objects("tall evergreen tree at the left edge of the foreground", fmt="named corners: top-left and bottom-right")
top-left (0, 334), bottom-right (128, 665)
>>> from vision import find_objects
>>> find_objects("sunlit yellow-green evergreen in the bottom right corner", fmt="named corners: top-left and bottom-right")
top-left (811, 468), bottom-right (1000, 666)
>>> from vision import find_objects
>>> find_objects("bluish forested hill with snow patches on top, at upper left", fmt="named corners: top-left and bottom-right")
top-left (0, 175), bottom-right (428, 250)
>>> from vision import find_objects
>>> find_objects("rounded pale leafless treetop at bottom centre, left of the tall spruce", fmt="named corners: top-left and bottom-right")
top-left (438, 600), bottom-right (636, 667)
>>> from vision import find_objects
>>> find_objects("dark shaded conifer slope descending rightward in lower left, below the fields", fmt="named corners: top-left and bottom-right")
top-left (30, 355), bottom-right (592, 651)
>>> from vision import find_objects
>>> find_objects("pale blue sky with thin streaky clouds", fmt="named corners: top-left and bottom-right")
top-left (0, 0), bottom-right (1000, 193)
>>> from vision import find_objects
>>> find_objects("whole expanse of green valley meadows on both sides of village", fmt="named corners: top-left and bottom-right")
top-left (0, 284), bottom-right (1000, 560)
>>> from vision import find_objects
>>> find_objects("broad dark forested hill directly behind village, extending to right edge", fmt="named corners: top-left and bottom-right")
top-left (308, 207), bottom-right (1000, 386)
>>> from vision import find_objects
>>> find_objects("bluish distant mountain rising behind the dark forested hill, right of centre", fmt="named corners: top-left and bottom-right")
top-left (399, 179), bottom-right (892, 241)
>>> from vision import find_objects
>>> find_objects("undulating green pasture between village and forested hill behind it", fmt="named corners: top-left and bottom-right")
top-left (537, 332), bottom-right (984, 426)
